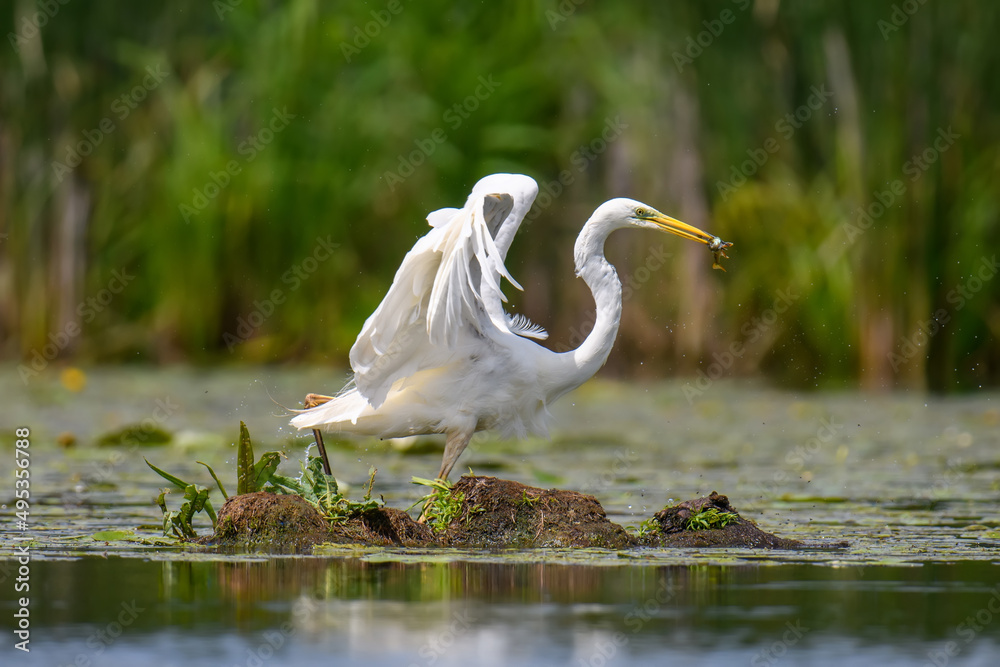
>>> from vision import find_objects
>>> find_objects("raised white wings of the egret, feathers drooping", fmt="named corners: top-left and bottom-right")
top-left (350, 174), bottom-right (547, 407)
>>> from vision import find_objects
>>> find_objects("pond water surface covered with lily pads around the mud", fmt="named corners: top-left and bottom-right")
top-left (0, 368), bottom-right (1000, 667)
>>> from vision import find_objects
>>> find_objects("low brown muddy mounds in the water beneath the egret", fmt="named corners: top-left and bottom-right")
top-left (203, 476), bottom-right (828, 553)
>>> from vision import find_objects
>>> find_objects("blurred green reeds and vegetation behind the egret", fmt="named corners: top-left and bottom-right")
top-left (0, 0), bottom-right (1000, 390)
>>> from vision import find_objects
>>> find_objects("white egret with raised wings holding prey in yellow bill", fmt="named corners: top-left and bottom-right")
top-left (292, 174), bottom-right (731, 479)
